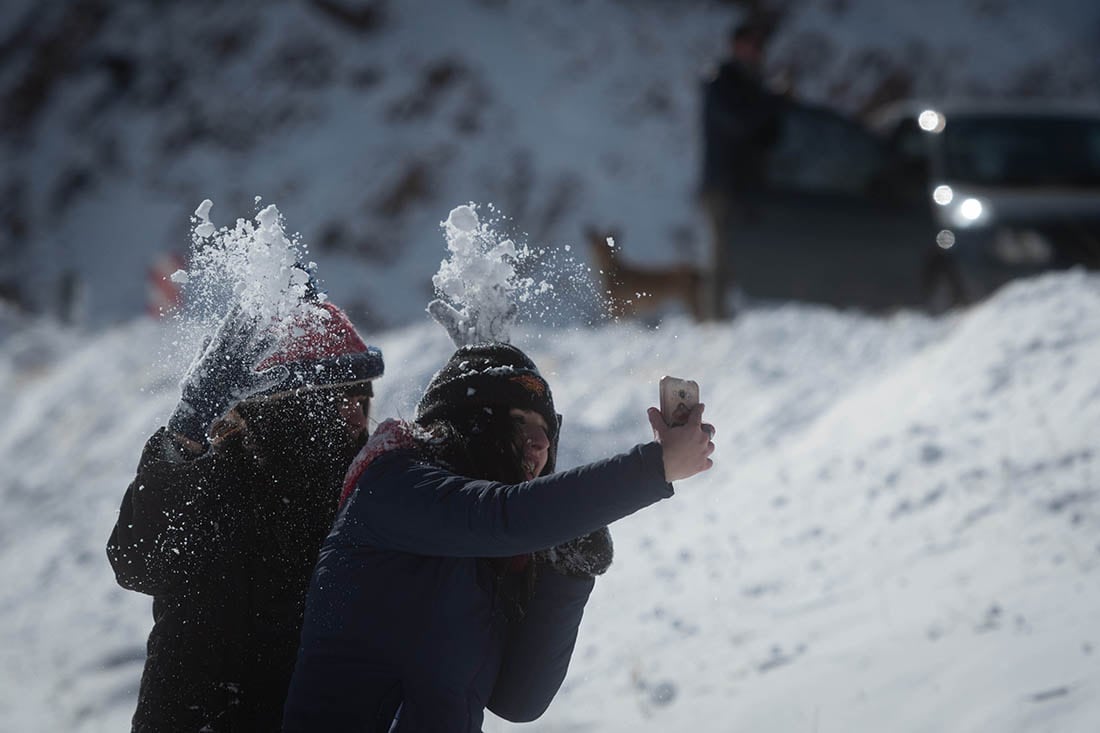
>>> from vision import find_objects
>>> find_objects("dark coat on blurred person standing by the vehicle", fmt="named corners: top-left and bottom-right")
top-left (702, 61), bottom-right (782, 192)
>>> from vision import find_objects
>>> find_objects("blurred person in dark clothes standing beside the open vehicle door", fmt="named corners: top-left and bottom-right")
top-left (700, 23), bottom-right (782, 318)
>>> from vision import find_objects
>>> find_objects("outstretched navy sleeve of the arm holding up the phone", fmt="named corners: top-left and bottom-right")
top-left (330, 442), bottom-right (672, 557)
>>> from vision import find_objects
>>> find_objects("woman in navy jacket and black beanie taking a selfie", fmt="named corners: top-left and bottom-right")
top-left (284, 343), bottom-right (714, 733)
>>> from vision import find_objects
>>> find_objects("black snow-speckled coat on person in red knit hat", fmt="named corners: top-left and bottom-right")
top-left (107, 413), bottom-right (358, 732)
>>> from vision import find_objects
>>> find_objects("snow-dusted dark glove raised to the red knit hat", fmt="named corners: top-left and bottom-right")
top-left (168, 308), bottom-right (289, 446)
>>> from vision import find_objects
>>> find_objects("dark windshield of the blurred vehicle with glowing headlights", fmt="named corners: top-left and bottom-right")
top-left (942, 116), bottom-right (1100, 187)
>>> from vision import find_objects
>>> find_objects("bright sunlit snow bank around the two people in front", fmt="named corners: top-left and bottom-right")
top-left (0, 273), bottom-right (1100, 733)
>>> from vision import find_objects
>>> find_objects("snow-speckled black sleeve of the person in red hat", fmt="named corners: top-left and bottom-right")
top-left (107, 428), bottom-right (231, 595)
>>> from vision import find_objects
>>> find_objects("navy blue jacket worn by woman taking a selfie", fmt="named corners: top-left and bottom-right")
top-left (284, 435), bottom-right (672, 733)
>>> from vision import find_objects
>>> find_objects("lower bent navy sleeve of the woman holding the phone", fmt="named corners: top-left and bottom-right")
top-left (488, 567), bottom-right (595, 723)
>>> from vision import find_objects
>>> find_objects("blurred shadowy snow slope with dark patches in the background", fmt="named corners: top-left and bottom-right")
top-left (0, 0), bottom-right (1100, 326)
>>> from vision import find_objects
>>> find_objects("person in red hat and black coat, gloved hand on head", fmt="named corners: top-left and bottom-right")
top-left (107, 303), bottom-right (383, 733)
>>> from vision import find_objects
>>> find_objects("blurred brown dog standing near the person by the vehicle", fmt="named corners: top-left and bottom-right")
top-left (585, 227), bottom-right (705, 320)
